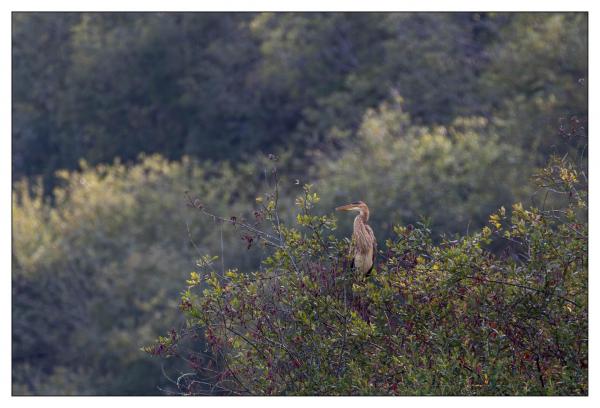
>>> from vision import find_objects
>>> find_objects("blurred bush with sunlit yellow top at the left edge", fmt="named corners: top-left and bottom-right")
top-left (13, 156), bottom-right (270, 393)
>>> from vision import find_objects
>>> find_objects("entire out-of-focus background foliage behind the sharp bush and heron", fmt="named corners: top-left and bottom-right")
top-left (12, 13), bottom-right (588, 394)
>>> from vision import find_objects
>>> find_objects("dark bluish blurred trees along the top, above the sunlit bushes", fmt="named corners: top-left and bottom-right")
top-left (13, 13), bottom-right (587, 183)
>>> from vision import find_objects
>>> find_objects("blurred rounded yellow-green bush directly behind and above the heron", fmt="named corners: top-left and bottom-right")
top-left (315, 99), bottom-right (531, 233)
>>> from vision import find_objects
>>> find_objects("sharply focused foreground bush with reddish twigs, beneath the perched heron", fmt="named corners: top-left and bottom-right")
top-left (145, 155), bottom-right (588, 395)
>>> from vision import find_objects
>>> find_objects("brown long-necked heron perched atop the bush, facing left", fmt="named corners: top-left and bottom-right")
top-left (336, 201), bottom-right (377, 277)
